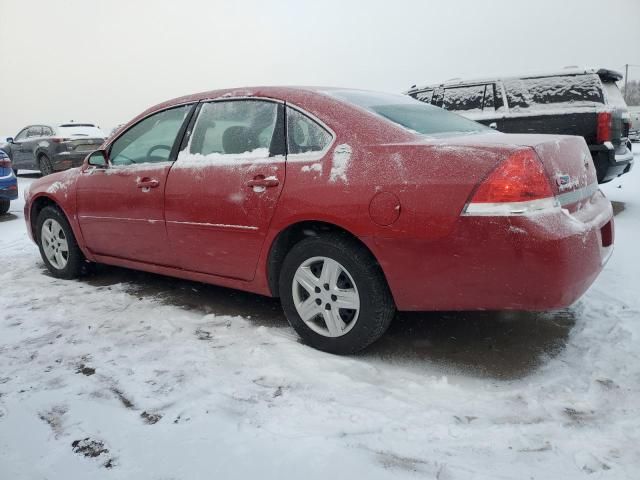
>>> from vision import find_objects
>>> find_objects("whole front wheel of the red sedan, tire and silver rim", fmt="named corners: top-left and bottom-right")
top-left (36, 206), bottom-right (86, 279)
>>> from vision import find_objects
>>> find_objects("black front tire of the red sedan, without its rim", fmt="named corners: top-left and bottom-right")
top-left (34, 206), bottom-right (88, 280)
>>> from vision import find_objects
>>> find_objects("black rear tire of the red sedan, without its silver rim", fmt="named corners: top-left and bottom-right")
top-left (279, 234), bottom-right (396, 355)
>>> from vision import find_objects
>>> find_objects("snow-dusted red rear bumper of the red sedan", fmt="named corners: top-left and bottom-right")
top-left (372, 192), bottom-right (614, 311)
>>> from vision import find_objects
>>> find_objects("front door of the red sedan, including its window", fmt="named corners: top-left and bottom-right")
top-left (76, 105), bottom-right (195, 266)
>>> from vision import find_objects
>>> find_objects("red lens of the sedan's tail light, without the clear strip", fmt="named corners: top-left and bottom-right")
top-left (471, 149), bottom-right (553, 203)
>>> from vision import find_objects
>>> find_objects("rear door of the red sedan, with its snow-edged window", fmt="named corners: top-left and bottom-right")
top-left (165, 100), bottom-right (285, 280)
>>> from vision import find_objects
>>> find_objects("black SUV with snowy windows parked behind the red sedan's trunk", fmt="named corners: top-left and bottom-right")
top-left (407, 68), bottom-right (633, 183)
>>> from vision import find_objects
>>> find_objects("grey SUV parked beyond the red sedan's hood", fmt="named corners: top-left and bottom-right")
top-left (5, 123), bottom-right (105, 175)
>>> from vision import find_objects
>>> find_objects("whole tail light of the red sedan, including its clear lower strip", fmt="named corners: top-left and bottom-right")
top-left (464, 148), bottom-right (556, 215)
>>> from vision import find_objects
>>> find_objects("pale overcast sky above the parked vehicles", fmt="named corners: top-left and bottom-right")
top-left (0, 0), bottom-right (640, 136)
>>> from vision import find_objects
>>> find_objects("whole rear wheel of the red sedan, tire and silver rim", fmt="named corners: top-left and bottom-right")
top-left (279, 234), bottom-right (395, 354)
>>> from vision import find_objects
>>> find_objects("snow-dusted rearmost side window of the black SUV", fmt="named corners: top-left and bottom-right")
top-left (504, 74), bottom-right (604, 109)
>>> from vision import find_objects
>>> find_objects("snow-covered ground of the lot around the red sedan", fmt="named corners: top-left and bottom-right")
top-left (0, 145), bottom-right (640, 480)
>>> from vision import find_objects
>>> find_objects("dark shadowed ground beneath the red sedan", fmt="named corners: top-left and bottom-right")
top-left (85, 265), bottom-right (576, 380)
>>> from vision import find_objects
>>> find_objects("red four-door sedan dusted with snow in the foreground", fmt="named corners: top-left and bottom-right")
top-left (25, 87), bottom-right (613, 353)
